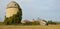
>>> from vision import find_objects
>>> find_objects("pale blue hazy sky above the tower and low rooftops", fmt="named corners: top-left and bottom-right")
top-left (0, 0), bottom-right (60, 22)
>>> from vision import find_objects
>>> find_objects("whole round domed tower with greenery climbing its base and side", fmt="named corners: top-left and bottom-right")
top-left (4, 1), bottom-right (22, 24)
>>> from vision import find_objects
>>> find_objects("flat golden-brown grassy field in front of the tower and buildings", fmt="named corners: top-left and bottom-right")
top-left (0, 25), bottom-right (60, 29)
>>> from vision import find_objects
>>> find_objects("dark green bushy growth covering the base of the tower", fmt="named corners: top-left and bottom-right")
top-left (4, 12), bottom-right (22, 25)
